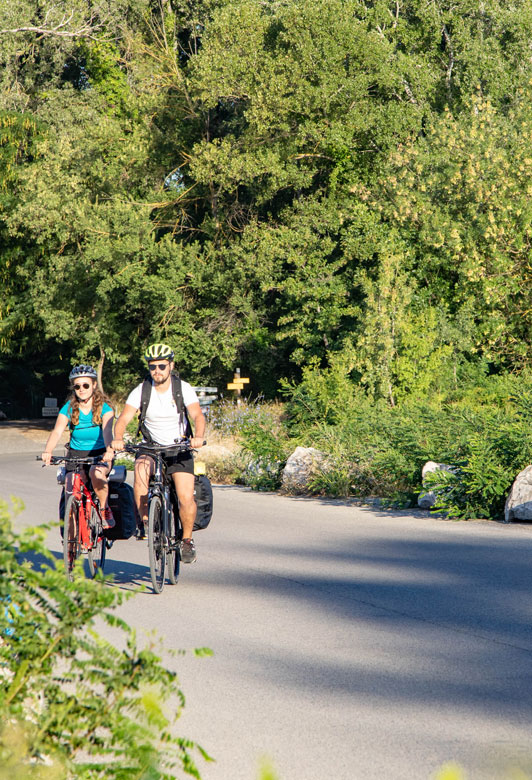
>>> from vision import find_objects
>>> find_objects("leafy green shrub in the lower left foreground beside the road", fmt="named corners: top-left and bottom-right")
top-left (0, 502), bottom-right (206, 780)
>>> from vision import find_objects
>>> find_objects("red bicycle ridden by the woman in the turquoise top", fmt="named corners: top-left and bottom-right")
top-left (37, 455), bottom-right (107, 580)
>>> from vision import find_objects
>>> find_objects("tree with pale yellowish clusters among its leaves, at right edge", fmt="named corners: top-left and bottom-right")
top-left (378, 91), bottom-right (532, 368)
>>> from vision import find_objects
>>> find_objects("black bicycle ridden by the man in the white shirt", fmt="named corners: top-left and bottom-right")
top-left (125, 440), bottom-right (192, 593)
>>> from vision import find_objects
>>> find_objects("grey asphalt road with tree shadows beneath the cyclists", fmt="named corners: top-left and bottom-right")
top-left (0, 441), bottom-right (532, 780)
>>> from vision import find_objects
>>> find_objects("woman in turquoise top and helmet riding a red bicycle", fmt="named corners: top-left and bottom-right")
top-left (41, 365), bottom-right (115, 528)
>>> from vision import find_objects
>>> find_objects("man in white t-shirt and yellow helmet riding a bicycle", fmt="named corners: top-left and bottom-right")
top-left (111, 344), bottom-right (205, 563)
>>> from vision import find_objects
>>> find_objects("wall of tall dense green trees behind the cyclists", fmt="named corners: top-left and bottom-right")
top-left (4, 0), bottom-right (532, 422)
